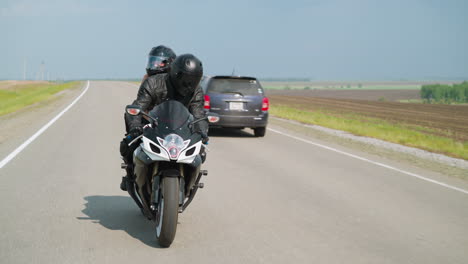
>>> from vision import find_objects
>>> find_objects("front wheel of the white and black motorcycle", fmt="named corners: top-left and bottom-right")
top-left (156, 177), bottom-right (179, 247)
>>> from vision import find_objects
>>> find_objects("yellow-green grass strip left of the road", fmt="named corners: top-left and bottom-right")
top-left (0, 82), bottom-right (79, 116)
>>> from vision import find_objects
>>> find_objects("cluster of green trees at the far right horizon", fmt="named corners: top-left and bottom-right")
top-left (421, 81), bottom-right (468, 104)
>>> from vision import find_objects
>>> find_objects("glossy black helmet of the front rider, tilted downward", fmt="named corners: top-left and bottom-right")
top-left (169, 54), bottom-right (203, 96)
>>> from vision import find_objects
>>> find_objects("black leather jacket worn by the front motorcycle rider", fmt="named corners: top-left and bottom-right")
top-left (125, 73), bottom-right (208, 134)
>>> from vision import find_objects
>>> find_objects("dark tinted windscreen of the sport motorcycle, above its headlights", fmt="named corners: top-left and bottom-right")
top-left (149, 100), bottom-right (191, 130)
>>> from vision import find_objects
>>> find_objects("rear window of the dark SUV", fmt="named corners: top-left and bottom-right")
top-left (208, 79), bottom-right (263, 96)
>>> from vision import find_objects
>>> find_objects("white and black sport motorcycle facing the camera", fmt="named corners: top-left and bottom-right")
top-left (122, 100), bottom-right (208, 247)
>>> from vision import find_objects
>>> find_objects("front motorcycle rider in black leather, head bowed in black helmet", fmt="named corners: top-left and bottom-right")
top-left (120, 54), bottom-right (208, 191)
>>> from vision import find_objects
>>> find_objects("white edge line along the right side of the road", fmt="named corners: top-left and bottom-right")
top-left (268, 128), bottom-right (468, 194)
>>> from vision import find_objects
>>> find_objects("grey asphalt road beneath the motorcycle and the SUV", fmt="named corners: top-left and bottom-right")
top-left (0, 82), bottom-right (468, 263)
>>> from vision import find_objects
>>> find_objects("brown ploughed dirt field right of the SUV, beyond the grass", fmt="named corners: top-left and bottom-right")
top-left (267, 90), bottom-right (468, 142)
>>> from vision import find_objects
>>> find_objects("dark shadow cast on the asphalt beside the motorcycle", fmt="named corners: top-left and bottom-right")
top-left (77, 195), bottom-right (160, 248)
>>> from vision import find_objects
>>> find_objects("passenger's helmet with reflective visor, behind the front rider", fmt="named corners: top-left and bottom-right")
top-left (146, 45), bottom-right (176, 75)
